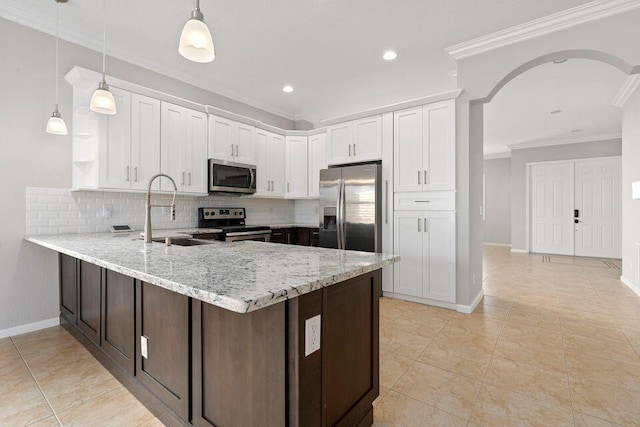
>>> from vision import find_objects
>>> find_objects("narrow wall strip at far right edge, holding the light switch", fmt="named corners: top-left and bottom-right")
top-left (622, 90), bottom-right (640, 289)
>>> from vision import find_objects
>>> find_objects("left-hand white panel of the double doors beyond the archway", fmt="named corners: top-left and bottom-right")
top-left (530, 162), bottom-right (574, 255)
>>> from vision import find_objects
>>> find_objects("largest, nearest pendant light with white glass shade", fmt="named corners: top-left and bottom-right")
top-left (178, 0), bottom-right (216, 63)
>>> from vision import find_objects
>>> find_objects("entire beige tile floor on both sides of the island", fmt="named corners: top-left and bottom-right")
top-left (0, 247), bottom-right (640, 427)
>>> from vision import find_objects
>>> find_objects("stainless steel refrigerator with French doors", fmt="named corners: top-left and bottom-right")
top-left (320, 163), bottom-right (382, 252)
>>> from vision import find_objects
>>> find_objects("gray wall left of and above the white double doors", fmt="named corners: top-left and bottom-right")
top-left (511, 139), bottom-right (622, 250)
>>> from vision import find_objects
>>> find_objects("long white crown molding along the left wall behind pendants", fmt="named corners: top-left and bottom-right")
top-left (0, 2), bottom-right (296, 121)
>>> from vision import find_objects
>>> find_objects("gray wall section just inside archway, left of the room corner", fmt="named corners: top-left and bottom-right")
top-left (482, 158), bottom-right (511, 245)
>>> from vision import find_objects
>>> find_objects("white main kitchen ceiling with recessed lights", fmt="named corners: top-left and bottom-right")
top-left (0, 0), bottom-right (588, 121)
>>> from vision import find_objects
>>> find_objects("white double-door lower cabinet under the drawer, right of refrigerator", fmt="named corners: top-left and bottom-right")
top-left (393, 210), bottom-right (456, 304)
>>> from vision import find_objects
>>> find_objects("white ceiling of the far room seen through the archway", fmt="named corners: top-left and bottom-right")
top-left (484, 59), bottom-right (627, 156)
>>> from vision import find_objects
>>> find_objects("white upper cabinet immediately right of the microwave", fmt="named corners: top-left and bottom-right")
top-left (255, 129), bottom-right (286, 197)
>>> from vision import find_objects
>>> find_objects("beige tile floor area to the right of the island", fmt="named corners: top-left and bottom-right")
top-left (375, 247), bottom-right (640, 427)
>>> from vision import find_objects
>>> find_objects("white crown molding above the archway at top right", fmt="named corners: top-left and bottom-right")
top-left (445, 0), bottom-right (640, 60)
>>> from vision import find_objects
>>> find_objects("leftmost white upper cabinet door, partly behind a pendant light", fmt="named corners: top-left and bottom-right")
top-left (98, 87), bottom-right (131, 189)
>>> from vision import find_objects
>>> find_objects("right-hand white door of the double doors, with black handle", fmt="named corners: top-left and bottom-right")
top-left (574, 157), bottom-right (622, 258)
